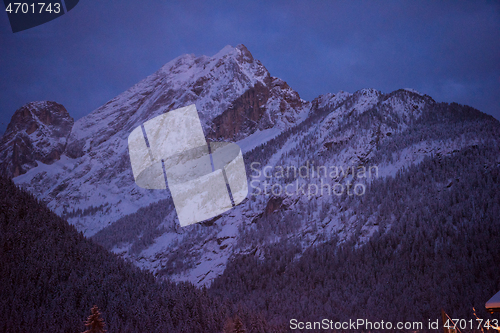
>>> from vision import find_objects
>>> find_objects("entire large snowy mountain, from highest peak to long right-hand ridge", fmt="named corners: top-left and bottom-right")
top-left (1, 46), bottom-right (499, 284)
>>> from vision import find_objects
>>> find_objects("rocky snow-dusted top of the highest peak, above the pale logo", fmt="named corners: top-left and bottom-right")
top-left (67, 45), bottom-right (308, 158)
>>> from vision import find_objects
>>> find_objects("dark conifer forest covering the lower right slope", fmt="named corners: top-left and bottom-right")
top-left (210, 146), bottom-right (500, 332)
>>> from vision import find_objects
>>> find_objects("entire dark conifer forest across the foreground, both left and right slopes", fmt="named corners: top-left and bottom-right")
top-left (0, 139), bottom-right (500, 332)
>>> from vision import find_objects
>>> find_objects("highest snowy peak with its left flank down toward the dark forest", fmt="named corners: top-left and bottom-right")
top-left (3, 45), bottom-right (310, 235)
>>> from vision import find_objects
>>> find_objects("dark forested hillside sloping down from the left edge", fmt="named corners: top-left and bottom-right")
top-left (0, 177), bottom-right (280, 333)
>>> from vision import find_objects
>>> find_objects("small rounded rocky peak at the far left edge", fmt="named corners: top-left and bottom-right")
top-left (0, 101), bottom-right (74, 177)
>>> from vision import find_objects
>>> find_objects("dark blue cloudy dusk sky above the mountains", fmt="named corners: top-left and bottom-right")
top-left (0, 0), bottom-right (500, 132)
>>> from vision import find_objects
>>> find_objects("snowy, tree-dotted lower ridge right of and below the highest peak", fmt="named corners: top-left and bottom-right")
top-left (94, 89), bottom-right (500, 284)
